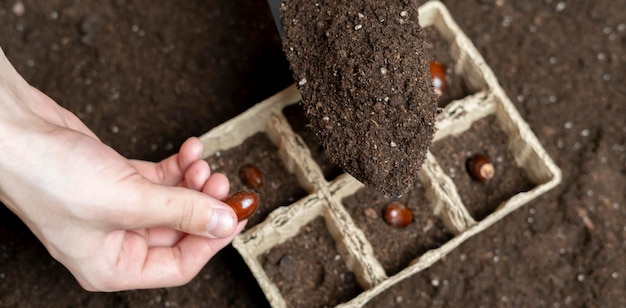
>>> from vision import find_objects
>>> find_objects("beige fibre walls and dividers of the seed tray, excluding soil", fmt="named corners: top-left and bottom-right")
top-left (201, 1), bottom-right (561, 307)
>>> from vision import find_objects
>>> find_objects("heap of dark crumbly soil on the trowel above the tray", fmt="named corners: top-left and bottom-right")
top-left (281, 0), bottom-right (437, 196)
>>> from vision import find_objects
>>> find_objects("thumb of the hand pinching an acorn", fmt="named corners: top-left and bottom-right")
top-left (125, 181), bottom-right (238, 238)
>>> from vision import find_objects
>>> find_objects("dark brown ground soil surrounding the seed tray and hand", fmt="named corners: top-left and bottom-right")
top-left (0, 0), bottom-right (626, 307)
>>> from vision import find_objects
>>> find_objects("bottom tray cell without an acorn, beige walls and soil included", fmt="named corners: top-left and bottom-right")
top-left (233, 191), bottom-right (372, 307)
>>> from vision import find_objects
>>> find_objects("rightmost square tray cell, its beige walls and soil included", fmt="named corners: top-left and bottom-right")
top-left (425, 87), bottom-right (561, 231)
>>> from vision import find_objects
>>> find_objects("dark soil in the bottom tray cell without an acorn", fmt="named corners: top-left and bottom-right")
top-left (259, 217), bottom-right (363, 307)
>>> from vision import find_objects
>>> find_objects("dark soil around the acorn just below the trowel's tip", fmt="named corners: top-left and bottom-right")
top-left (343, 182), bottom-right (452, 276)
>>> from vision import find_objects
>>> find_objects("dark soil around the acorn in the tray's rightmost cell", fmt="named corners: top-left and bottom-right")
top-left (431, 116), bottom-right (537, 221)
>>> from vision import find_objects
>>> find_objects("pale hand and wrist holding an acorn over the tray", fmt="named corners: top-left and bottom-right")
top-left (0, 49), bottom-right (245, 291)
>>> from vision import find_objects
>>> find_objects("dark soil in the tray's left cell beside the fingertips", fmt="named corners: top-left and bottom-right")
top-left (207, 133), bottom-right (307, 228)
